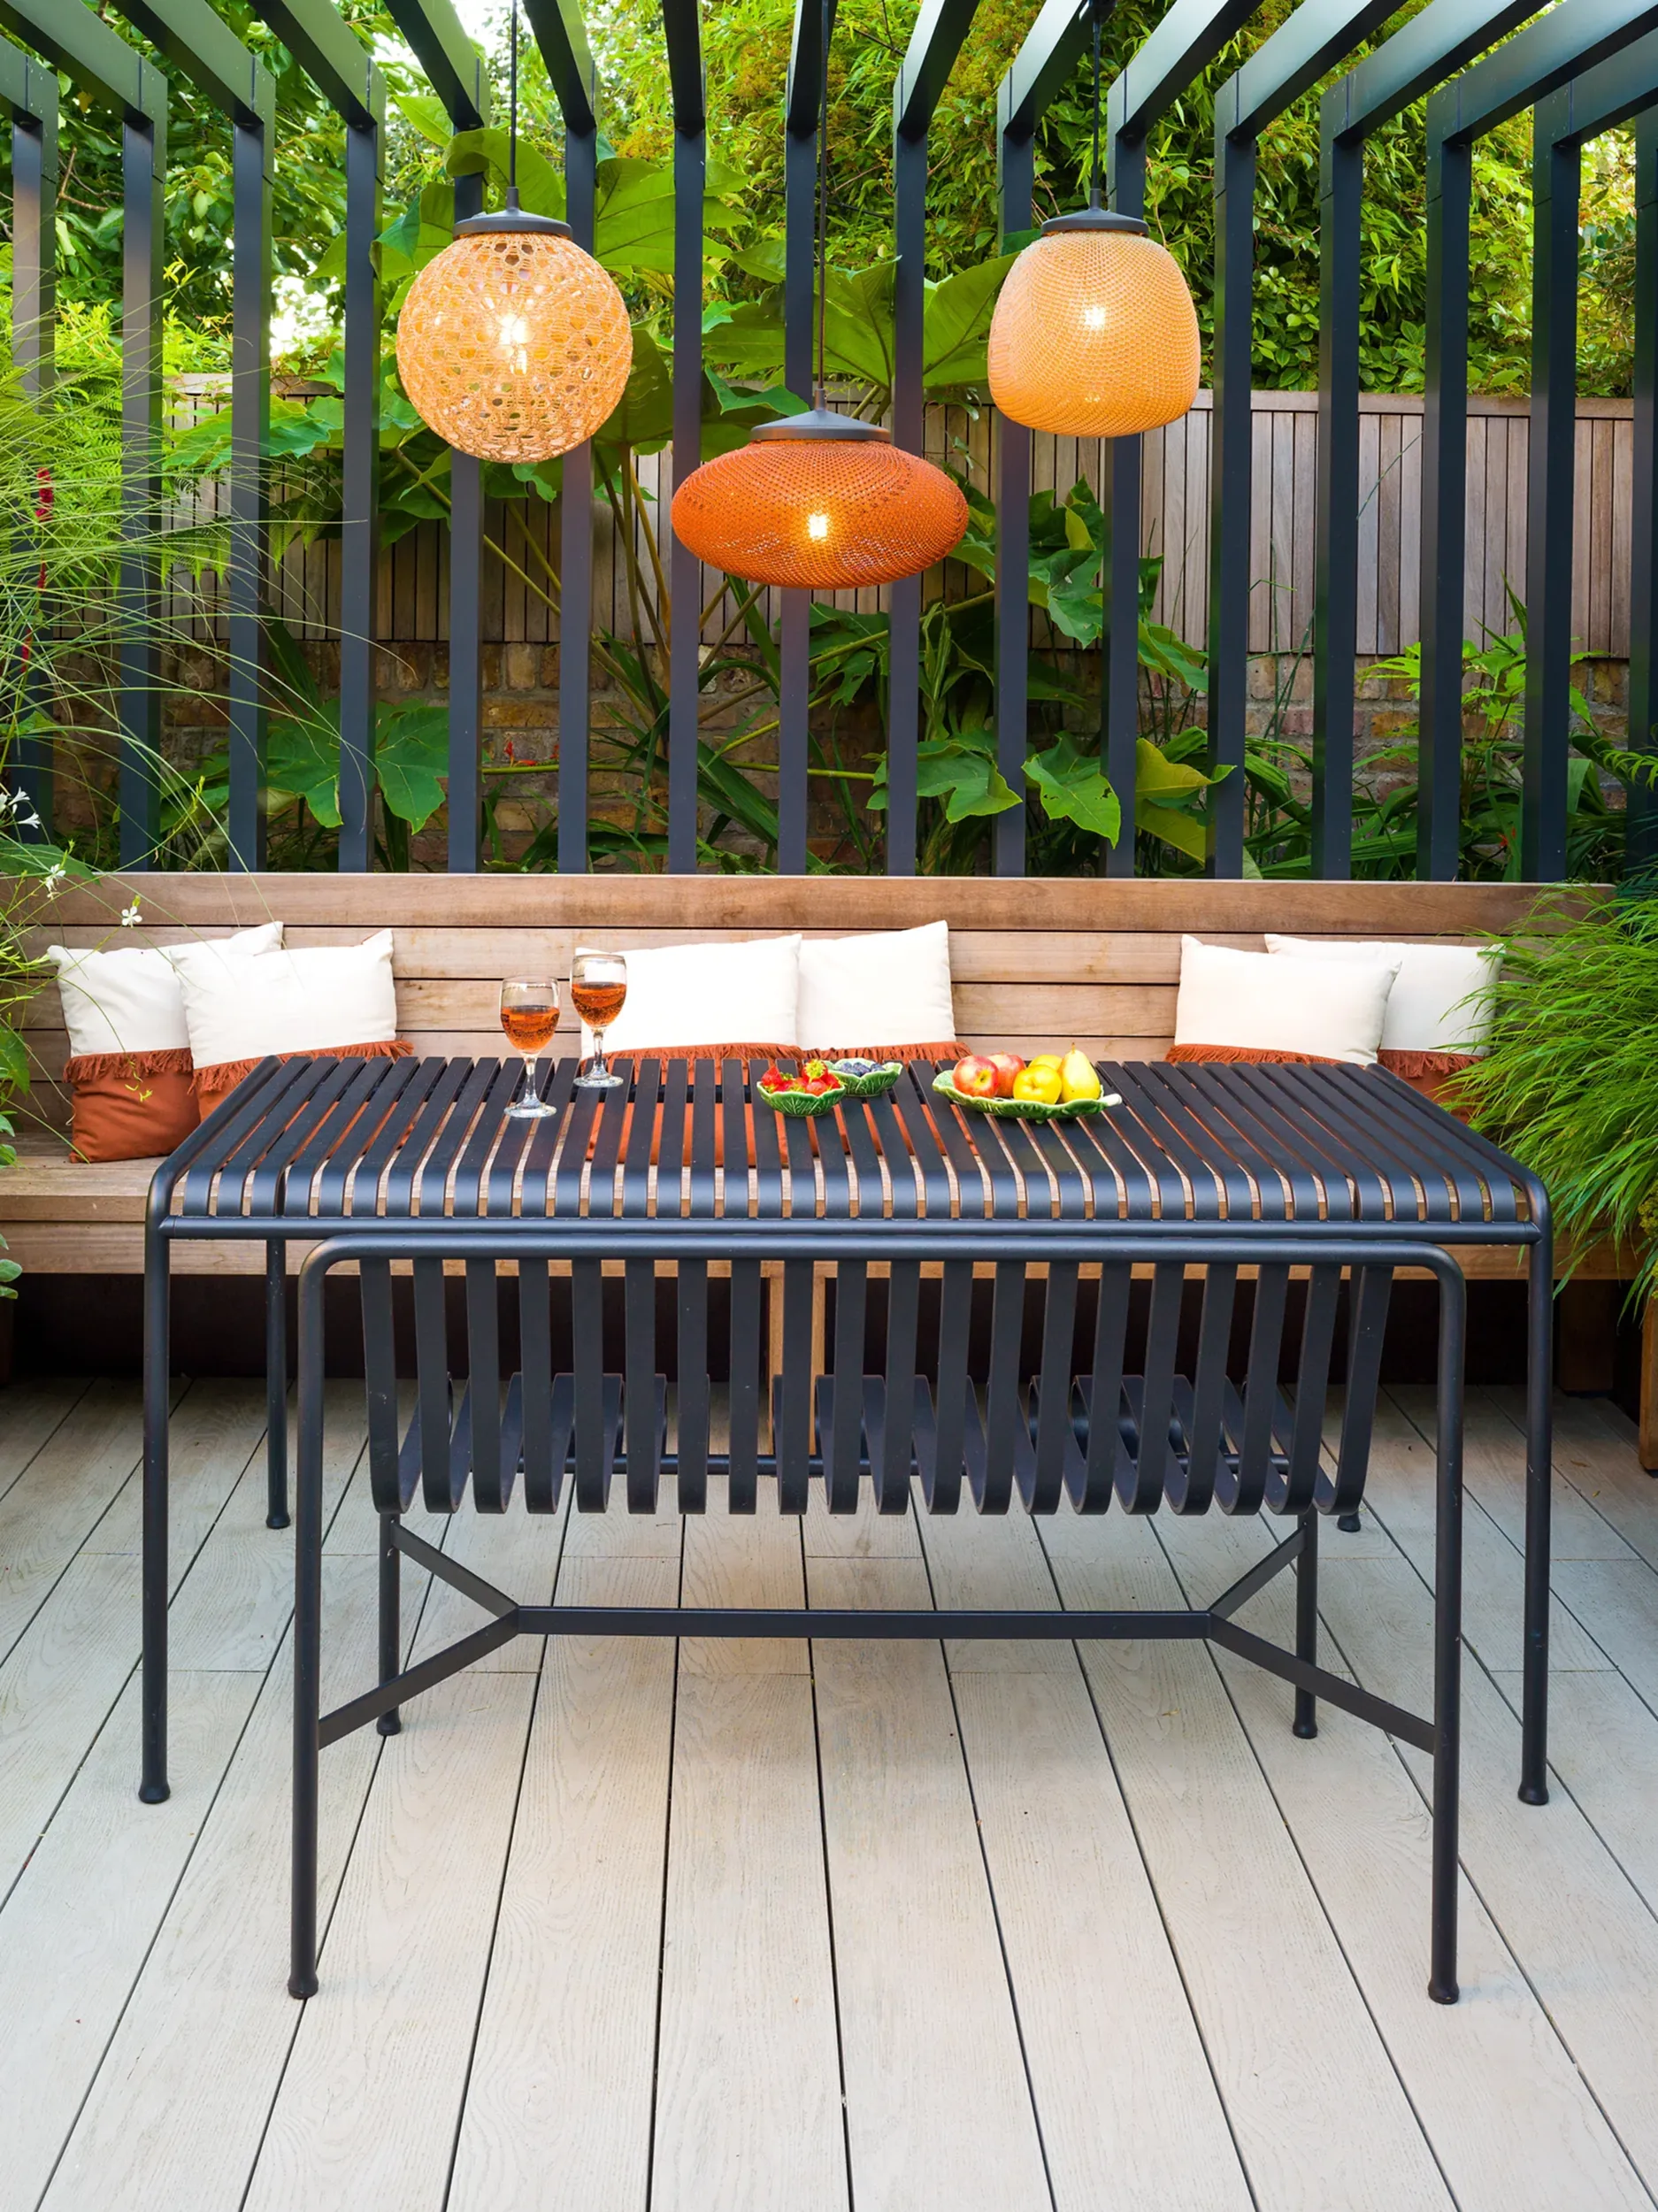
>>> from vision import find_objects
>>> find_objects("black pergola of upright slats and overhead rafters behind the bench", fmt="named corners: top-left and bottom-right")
top-left (0, 0), bottom-right (1658, 879)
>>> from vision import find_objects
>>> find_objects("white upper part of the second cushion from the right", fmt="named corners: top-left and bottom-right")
top-left (1174, 938), bottom-right (1400, 1069)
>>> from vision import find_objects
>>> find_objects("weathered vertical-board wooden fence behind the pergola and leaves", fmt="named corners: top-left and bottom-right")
top-left (162, 379), bottom-right (1634, 659)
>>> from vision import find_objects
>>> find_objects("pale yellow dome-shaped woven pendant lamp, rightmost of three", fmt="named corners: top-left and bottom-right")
top-left (988, 208), bottom-right (1201, 438)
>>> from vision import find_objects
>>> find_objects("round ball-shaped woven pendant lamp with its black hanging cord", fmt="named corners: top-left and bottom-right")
top-left (398, 7), bottom-right (633, 460)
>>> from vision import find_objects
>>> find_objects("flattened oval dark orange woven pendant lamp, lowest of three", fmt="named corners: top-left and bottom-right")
top-left (672, 407), bottom-right (968, 591)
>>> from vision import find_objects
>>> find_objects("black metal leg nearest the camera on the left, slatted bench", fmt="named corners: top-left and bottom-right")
top-left (288, 1270), bottom-right (326, 1998)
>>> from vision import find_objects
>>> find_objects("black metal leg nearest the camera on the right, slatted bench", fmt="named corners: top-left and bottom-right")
top-left (1428, 1274), bottom-right (1466, 2004)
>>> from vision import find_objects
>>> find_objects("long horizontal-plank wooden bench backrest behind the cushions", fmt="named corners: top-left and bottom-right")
top-left (27, 876), bottom-right (1539, 1122)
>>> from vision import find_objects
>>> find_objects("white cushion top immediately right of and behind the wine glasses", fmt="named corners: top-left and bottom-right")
top-left (577, 936), bottom-right (801, 1053)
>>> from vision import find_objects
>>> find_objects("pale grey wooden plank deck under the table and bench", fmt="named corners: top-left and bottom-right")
top-left (0, 1383), bottom-right (1658, 2212)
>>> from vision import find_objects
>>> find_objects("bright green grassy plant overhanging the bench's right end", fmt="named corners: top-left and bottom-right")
top-left (1457, 898), bottom-right (1658, 1301)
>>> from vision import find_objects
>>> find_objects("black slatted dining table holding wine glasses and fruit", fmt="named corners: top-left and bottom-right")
top-left (142, 1056), bottom-right (1552, 1803)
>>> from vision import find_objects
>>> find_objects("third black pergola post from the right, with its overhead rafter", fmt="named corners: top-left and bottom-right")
top-left (1417, 0), bottom-right (1658, 883)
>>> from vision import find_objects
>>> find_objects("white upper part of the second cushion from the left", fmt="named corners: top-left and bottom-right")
top-left (168, 929), bottom-right (398, 1069)
